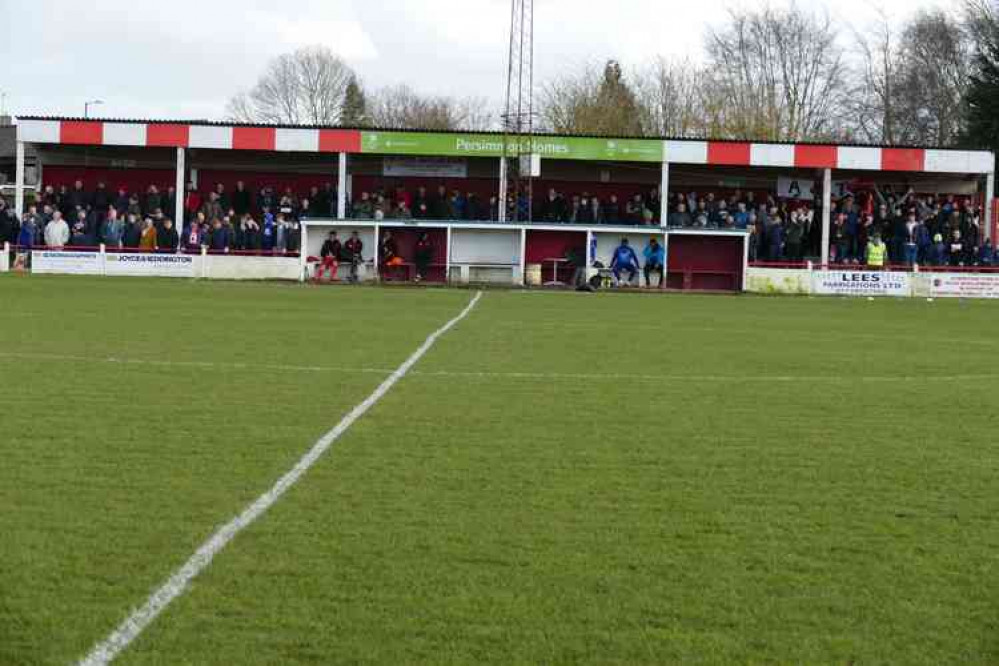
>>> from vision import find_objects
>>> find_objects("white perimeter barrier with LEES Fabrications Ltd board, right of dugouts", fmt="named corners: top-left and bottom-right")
top-left (746, 267), bottom-right (999, 298)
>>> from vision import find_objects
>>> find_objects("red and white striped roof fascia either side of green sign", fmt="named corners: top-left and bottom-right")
top-left (17, 120), bottom-right (995, 174)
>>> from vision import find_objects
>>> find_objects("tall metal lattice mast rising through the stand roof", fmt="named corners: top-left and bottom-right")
top-left (499, 0), bottom-right (534, 222)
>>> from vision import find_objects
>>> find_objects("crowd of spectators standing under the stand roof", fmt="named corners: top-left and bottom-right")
top-left (0, 180), bottom-right (999, 266)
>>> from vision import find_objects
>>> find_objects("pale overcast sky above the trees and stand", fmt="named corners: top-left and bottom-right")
top-left (0, 0), bottom-right (956, 119)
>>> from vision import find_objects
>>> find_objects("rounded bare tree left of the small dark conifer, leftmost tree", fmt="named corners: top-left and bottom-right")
top-left (226, 46), bottom-right (354, 125)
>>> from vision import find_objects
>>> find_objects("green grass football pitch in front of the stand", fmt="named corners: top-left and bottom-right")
top-left (0, 275), bottom-right (999, 666)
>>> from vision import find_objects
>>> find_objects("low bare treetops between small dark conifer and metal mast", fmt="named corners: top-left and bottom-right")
top-left (368, 84), bottom-right (496, 130)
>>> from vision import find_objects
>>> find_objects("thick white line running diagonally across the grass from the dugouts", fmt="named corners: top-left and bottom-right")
top-left (79, 291), bottom-right (482, 666)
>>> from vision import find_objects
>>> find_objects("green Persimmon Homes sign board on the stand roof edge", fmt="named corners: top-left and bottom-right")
top-left (361, 132), bottom-right (663, 162)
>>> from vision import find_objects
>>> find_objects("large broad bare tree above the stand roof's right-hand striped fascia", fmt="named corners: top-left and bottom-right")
top-left (707, 4), bottom-right (845, 141)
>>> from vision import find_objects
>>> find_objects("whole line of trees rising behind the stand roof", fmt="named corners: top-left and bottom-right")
top-left (227, 0), bottom-right (999, 154)
